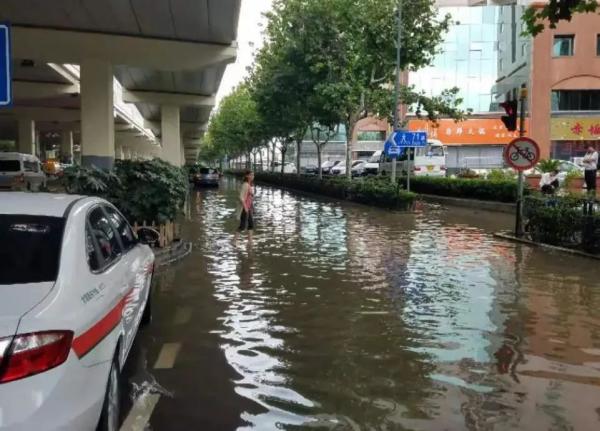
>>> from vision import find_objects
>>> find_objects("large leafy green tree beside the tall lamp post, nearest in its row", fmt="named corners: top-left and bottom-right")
top-left (267, 0), bottom-right (463, 176)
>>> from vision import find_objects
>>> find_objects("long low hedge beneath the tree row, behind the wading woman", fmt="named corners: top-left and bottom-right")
top-left (230, 171), bottom-right (416, 210)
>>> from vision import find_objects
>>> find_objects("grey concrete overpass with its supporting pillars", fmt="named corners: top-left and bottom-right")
top-left (0, 0), bottom-right (241, 168)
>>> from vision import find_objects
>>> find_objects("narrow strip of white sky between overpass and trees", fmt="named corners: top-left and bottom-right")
top-left (217, 0), bottom-right (272, 104)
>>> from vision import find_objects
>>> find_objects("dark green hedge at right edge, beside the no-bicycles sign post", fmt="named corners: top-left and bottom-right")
top-left (523, 195), bottom-right (600, 253)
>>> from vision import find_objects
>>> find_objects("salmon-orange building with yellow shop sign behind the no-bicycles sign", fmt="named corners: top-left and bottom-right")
top-left (530, 14), bottom-right (600, 160)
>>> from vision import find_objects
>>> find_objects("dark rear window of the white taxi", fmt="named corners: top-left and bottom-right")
top-left (0, 214), bottom-right (64, 285)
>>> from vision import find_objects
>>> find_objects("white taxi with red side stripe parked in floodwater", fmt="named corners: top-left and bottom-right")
top-left (0, 192), bottom-right (154, 431)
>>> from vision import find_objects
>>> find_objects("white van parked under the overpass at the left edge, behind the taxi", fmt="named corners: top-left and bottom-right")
top-left (0, 153), bottom-right (46, 191)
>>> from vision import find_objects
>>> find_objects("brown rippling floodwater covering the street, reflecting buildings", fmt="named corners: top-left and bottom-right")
top-left (124, 179), bottom-right (600, 430)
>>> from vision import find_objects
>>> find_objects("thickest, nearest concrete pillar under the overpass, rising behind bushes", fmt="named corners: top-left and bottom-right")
top-left (81, 59), bottom-right (115, 169)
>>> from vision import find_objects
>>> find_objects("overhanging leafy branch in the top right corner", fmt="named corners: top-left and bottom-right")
top-left (523, 0), bottom-right (599, 36)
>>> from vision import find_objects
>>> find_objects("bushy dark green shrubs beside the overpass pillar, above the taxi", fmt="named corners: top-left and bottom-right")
top-left (64, 159), bottom-right (188, 223)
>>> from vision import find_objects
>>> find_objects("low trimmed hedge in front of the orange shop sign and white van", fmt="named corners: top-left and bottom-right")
top-left (400, 177), bottom-right (517, 202)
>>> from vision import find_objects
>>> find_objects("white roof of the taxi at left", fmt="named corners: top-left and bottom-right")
top-left (0, 192), bottom-right (84, 217)
